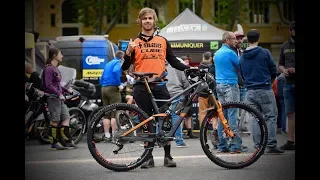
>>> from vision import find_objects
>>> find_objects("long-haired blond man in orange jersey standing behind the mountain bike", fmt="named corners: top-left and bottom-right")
top-left (122, 7), bottom-right (190, 168)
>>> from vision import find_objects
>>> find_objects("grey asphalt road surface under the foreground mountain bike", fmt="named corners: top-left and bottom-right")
top-left (25, 135), bottom-right (295, 180)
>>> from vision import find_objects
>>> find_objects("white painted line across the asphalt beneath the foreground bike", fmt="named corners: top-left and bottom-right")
top-left (25, 151), bottom-right (294, 164)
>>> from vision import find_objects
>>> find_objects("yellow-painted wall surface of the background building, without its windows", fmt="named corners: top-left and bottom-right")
top-left (35, 0), bottom-right (289, 47)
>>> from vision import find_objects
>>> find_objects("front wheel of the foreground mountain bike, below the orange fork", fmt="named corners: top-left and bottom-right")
top-left (200, 102), bottom-right (268, 169)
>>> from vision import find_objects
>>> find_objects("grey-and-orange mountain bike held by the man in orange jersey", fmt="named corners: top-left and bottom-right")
top-left (87, 68), bottom-right (268, 171)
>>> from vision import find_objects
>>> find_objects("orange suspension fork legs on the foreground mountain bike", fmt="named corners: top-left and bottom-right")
top-left (209, 93), bottom-right (236, 138)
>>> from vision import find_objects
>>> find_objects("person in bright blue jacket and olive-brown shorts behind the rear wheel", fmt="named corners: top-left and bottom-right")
top-left (100, 51), bottom-right (124, 141)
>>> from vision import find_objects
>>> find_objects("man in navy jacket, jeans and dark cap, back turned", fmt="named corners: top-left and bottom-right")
top-left (240, 29), bottom-right (284, 154)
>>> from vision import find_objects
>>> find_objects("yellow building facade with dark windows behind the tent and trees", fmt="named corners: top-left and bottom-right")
top-left (25, 0), bottom-right (295, 60)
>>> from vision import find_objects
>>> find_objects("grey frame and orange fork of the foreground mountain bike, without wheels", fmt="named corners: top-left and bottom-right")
top-left (121, 72), bottom-right (235, 142)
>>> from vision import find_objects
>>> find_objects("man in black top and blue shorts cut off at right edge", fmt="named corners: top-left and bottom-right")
top-left (279, 21), bottom-right (296, 150)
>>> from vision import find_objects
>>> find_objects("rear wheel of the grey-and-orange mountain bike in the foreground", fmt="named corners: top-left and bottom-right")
top-left (87, 103), bottom-right (153, 172)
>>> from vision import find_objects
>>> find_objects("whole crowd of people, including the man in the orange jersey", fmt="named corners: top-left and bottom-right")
top-left (26, 5), bottom-right (295, 168)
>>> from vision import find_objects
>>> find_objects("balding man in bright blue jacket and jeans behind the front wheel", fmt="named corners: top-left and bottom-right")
top-left (214, 31), bottom-right (247, 153)
